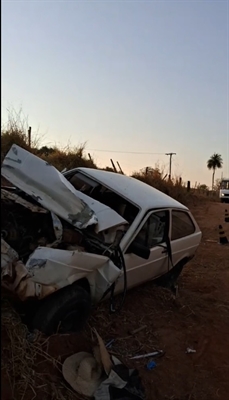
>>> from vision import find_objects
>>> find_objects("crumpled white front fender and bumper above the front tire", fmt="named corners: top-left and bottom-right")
top-left (1, 239), bottom-right (123, 302)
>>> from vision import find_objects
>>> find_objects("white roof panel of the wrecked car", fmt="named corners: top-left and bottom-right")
top-left (75, 168), bottom-right (188, 210)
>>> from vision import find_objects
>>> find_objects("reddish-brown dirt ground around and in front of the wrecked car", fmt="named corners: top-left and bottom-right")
top-left (2, 202), bottom-right (229, 400)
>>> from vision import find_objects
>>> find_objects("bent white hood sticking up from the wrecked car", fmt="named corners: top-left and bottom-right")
top-left (1, 144), bottom-right (128, 233)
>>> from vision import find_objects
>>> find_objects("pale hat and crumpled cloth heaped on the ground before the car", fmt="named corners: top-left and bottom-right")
top-left (62, 329), bottom-right (145, 400)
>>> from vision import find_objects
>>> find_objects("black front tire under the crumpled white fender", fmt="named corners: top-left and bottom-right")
top-left (32, 283), bottom-right (91, 336)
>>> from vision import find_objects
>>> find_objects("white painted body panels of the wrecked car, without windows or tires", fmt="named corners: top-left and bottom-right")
top-left (2, 145), bottom-right (201, 302)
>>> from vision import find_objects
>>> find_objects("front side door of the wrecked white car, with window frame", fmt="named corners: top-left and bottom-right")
top-left (116, 210), bottom-right (170, 292)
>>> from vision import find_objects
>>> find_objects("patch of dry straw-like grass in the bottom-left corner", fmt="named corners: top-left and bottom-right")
top-left (1, 299), bottom-right (87, 400)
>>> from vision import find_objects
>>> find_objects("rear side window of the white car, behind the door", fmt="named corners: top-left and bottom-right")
top-left (171, 211), bottom-right (195, 240)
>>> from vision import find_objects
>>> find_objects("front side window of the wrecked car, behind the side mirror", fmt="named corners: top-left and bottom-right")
top-left (134, 211), bottom-right (168, 248)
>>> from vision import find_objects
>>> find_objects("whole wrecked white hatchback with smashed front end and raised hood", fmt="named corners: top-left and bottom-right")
top-left (1, 145), bottom-right (201, 334)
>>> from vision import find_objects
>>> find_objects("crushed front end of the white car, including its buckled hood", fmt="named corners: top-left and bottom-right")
top-left (1, 145), bottom-right (128, 303)
